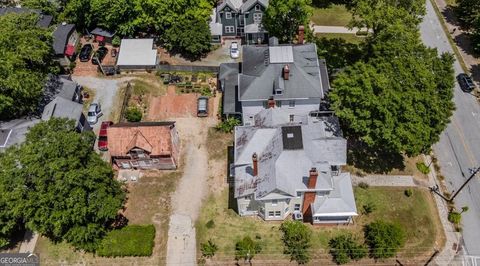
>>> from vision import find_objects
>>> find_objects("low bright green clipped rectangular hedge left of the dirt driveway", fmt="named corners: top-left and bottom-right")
top-left (97, 224), bottom-right (155, 257)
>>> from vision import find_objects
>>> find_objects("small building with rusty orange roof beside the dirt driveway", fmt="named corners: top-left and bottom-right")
top-left (107, 122), bottom-right (180, 169)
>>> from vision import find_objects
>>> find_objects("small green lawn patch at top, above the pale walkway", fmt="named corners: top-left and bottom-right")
top-left (311, 5), bottom-right (352, 26)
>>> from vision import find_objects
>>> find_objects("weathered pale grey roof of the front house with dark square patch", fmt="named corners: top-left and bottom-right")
top-left (233, 108), bottom-right (347, 199)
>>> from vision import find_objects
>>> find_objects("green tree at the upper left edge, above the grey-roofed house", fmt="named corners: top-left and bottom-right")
top-left (0, 14), bottom-right (52, 119)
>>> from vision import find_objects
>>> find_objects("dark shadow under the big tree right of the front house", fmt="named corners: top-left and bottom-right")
top-left (347, 140), bottom-right (405, 174)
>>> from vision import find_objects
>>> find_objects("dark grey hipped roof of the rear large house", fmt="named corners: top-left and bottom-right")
top-left (239, 44), bottom-right (328, 101)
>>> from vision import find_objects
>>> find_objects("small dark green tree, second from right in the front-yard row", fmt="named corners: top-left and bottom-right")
top-left (328, 234), bottom-right (368, 264)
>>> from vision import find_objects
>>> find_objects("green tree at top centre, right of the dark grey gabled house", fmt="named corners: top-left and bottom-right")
top-left (262, 0), bottom-right (312, 43)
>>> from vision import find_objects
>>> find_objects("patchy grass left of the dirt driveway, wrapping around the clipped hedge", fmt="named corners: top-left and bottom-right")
top-left (35, 171), bottom-right (182, 266)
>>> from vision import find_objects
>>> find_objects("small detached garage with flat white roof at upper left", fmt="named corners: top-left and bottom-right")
top-left (117, 39), bottom-right (157, 71)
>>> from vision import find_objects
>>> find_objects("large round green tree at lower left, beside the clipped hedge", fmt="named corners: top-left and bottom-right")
top-left (0, 118), bottom-right (125, 251)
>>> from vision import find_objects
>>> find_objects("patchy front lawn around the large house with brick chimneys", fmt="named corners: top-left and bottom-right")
top-left (196, 187), bottom-right (444, 264)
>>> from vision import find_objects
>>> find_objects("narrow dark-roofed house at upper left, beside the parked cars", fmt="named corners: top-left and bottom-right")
top-left (53, 23), bottom-right (80, 67)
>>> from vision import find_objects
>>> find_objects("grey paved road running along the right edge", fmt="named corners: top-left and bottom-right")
top-left (420, 1), bottom-right (480, 256)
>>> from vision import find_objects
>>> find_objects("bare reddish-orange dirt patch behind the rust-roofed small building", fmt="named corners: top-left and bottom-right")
top-left (148, 85), bottom-right (213, 121)
